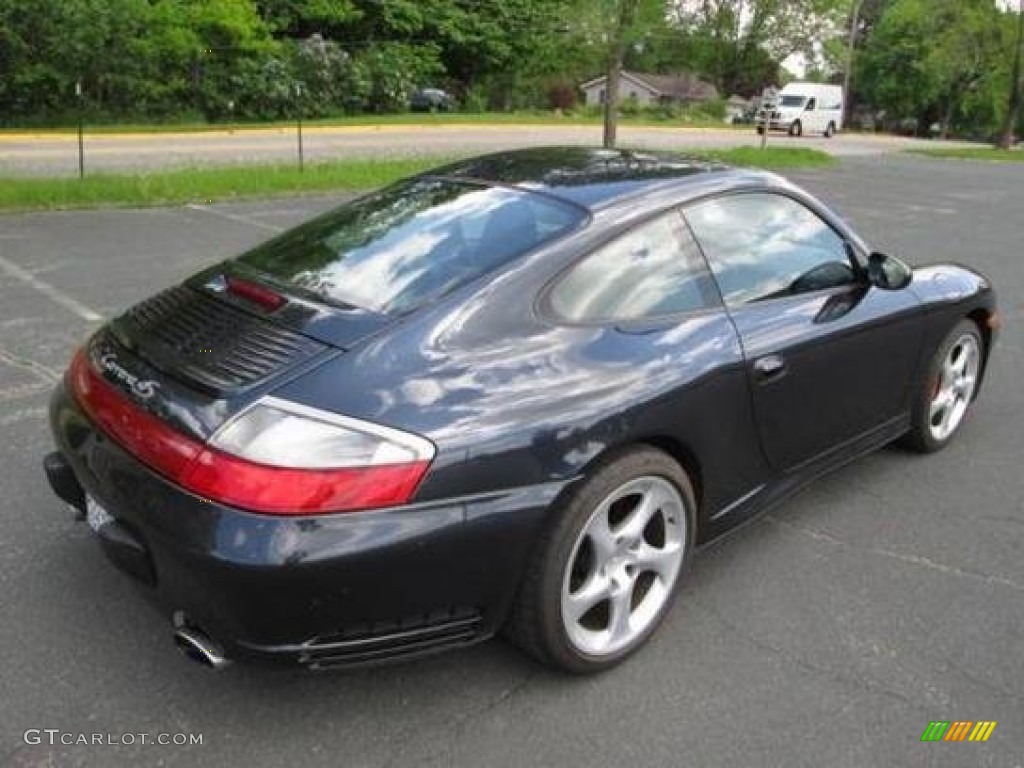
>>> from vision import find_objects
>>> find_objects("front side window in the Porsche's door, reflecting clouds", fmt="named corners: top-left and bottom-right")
top-left (685, 193), bottom-right (856, 306)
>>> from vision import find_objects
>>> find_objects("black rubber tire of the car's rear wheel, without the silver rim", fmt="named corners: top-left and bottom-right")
top-left (505, 445), bottom-right (696, 674)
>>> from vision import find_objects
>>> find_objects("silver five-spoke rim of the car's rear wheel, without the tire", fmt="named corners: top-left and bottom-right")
top-left (561, 475), bottom-right (687, 656)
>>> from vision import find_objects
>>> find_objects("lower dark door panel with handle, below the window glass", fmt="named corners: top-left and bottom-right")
top-left (731, 287), bottom-right (922, 470)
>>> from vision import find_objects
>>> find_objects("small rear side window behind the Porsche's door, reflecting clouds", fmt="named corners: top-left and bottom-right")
top-left (549, 212), bottom-right (720, 323)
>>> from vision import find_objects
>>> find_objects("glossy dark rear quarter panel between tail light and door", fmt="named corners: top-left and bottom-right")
top-left (278, 228), bottom-right (765, 540)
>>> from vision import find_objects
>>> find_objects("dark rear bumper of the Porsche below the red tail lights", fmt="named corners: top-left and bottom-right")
top-left (46, 385), bottom-right (562, 667)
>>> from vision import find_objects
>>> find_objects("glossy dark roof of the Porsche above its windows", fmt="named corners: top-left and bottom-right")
top-left (426, 146), bottom-right (751, 209)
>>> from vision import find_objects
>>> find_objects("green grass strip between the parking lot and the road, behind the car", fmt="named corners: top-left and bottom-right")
top-left (0, 146), bottom-right (836, 211)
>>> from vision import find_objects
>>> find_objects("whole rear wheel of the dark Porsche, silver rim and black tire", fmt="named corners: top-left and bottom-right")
top-left (508, 446), bottom-right (695, 674)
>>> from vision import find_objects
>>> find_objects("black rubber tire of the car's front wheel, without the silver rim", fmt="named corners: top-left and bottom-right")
top-left (901, 319), bottom-right (985, 454)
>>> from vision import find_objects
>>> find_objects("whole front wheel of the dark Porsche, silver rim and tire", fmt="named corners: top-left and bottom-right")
top-left (904, 319), bottom-right (984, 453)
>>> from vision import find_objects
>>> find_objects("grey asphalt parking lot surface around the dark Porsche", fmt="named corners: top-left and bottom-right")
top-left (0, 156), bottom-right (1024, 768)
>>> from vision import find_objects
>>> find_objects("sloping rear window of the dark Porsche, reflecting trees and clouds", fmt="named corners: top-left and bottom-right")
top-left (239, 178), bottom-right (585, 314)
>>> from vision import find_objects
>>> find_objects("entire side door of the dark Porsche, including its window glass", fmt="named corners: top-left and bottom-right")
top-left (685, 190), bottom-right (922, 470)
